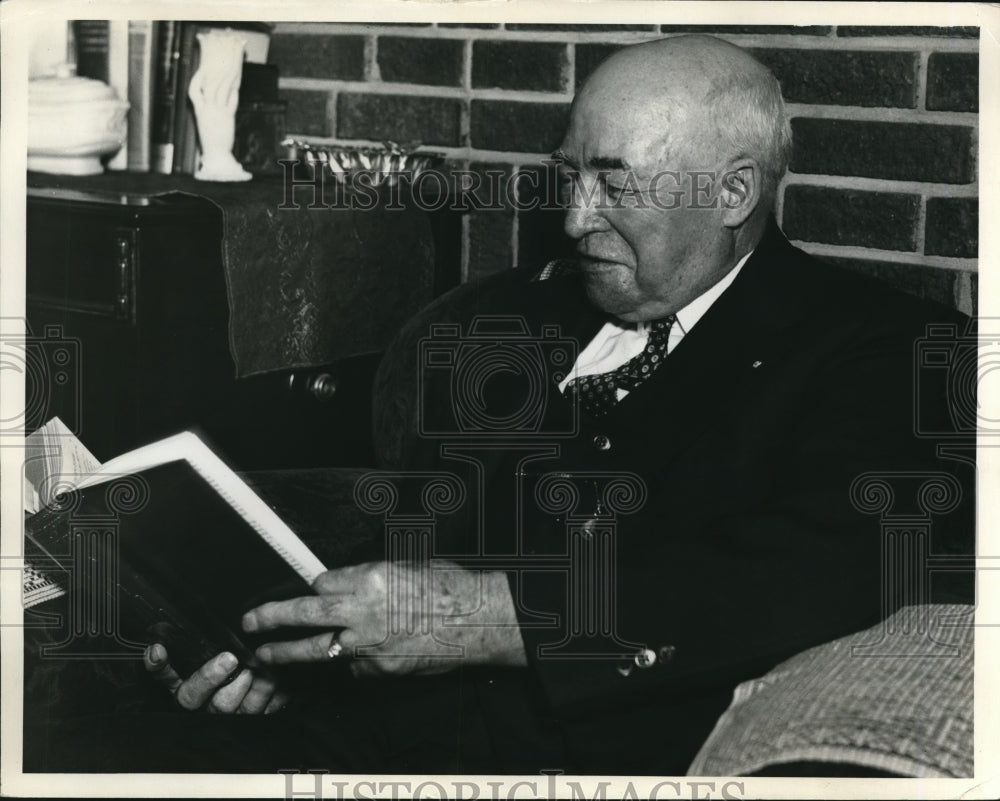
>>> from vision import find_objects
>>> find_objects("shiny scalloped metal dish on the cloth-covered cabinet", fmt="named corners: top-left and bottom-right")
top-left (281, 139), bottom-right (445, 186)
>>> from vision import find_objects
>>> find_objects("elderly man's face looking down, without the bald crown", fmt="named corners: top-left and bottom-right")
top-left (555, 93), bottom-right (732, 322)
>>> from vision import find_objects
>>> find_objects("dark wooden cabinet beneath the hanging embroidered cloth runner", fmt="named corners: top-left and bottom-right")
top-left (27, 177), bottom-right (460, 469)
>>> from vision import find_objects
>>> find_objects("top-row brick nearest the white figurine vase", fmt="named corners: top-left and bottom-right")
top-left (267, 33), bottom-right (365, 81)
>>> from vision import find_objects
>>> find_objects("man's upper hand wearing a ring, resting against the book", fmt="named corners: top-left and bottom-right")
top-left (243, 562), bottom-right (527, 675)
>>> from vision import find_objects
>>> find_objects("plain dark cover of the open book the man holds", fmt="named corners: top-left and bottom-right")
top-left (25, 460), bottom-right (315, 675)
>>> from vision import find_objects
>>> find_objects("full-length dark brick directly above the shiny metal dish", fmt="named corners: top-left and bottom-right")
top-left (337, 92), bottom-right (462, 146)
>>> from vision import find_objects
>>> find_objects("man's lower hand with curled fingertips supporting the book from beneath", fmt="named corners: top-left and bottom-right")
top-left (143, 643), bottom-right (288, 715)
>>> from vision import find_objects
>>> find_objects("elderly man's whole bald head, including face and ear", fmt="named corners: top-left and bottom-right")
top-left (554, 36), bottom-right (791, 322)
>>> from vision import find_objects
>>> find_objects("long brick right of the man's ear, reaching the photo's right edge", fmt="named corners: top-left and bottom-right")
top-left (791, 117), bottom-right (975, 184)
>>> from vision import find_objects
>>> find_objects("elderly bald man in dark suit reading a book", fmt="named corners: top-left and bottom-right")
top-left (141, 36), bottom-right (964, 774)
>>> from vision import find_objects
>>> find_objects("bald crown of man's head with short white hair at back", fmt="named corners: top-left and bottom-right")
top-left (574, 36), bottom-right (791, 207)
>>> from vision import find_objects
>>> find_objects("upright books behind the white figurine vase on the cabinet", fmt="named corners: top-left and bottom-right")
top-left (73, 20), bottom-right (276, 175)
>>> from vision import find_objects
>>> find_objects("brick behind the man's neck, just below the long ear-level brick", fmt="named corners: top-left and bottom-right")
top-left (783, 185), bottom-right (920, 251)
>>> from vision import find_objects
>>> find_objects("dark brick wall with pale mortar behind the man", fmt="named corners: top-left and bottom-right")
top-left (270, 23), bottom-right (979, 312)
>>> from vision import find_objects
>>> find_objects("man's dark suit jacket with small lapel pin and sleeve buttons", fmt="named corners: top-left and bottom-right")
top-left (392, 224), bottom-right (973, 774)
